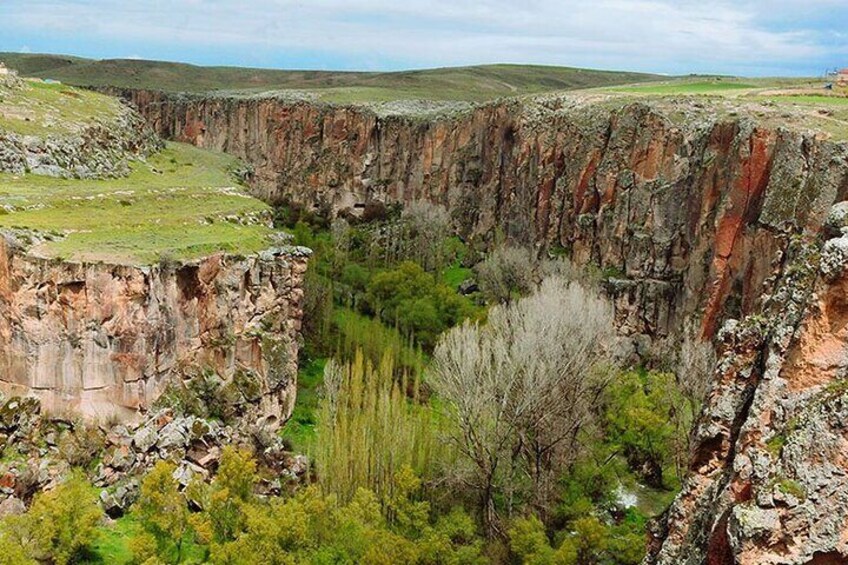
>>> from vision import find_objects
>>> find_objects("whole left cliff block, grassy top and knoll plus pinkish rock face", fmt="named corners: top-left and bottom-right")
top-left (0, 79), bottom-right (309, 430)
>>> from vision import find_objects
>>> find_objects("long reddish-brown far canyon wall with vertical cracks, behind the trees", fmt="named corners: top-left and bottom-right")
top-left (119, 91), bottom-right (848, 338)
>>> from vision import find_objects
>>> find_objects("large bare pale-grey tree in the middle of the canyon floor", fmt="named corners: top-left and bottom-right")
top-left (429, 276), bottom-right (615, 535)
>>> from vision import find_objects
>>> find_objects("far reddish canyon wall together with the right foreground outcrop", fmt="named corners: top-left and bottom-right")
top-left (123, 92), bottom-right (848, 564)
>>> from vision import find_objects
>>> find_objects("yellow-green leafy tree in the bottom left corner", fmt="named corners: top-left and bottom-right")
top-left (0, 472), bottom-right (103, 565)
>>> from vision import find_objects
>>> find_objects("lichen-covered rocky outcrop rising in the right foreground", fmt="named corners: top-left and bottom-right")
top-left (650, 213), bottom-right (848, 565)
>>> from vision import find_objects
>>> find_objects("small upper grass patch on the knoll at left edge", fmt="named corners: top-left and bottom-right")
top-left (0, 81), bottom-right (125, 137)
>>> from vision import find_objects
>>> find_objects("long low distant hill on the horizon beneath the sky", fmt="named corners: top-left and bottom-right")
top-left (0, 53), bottom-right (668, 102)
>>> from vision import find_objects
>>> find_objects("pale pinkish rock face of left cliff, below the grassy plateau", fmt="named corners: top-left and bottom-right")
top-left (0, 236), bottom-right (307, 426)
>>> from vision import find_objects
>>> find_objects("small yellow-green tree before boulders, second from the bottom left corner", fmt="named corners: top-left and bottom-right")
top-left (134, 461), bottom-right (191, 563)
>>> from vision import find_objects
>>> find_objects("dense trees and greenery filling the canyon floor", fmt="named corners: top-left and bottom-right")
top-left (0, 199), bottom-right (703, 564)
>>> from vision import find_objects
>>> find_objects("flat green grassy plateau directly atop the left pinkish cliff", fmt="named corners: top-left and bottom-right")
top-left (0, 143), bottom-right (273, 264)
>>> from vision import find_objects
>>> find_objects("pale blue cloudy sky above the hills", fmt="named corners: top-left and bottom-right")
top-left (0, 0), bottom-right (848, 76)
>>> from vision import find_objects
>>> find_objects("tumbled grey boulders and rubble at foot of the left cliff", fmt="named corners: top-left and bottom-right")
top-left (0, 393), bottom-right (309, 518)
